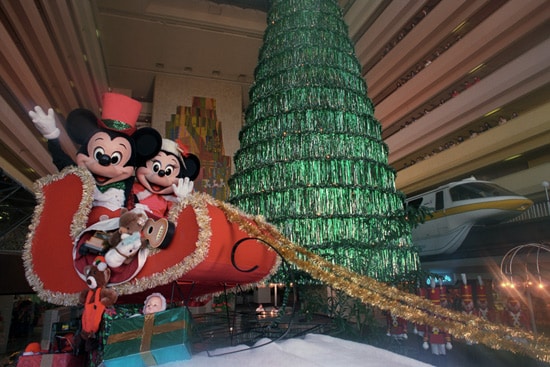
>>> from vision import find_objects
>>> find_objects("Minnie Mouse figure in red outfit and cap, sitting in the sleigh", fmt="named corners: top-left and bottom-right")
top-left (132, 139), bottom-right (200, 219)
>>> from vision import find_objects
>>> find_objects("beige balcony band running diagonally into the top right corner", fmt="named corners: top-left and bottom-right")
top-left (375, 0), bottom-right (548, 130)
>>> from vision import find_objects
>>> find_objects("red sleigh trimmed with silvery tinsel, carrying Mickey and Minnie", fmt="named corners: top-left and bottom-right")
top-left (23, 167), bottom-right (279, 305)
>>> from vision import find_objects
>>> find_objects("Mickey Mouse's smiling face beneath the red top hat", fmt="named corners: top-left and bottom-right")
top-left (76, 131), bottom-right (134, 186)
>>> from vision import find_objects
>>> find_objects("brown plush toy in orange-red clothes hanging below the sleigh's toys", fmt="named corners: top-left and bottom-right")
top-left (79, 256), bottom-right (118, 350)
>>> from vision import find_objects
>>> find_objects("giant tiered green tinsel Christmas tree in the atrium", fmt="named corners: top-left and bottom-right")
top-left (229, 0), bottom-right (419, 283)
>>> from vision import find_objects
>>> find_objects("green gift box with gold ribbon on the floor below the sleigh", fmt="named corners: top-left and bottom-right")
top-left (103, 307), bottom-right (191, 367)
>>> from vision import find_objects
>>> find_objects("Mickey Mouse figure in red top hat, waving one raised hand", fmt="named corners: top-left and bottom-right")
top-left (29, 93), bottom-right (162, 225)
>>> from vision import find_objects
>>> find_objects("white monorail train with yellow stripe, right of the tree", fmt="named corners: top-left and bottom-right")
top-left (406, 177), bottom-right (533, 257)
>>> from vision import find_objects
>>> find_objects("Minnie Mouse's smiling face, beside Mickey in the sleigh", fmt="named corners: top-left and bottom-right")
top-left (136, 151), bottom-right (181, 195)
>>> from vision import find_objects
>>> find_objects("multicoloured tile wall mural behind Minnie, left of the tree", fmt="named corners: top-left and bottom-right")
top-left (166, 97), bottom-right (231, 200)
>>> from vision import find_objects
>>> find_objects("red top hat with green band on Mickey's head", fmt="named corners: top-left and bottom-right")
top-left (99, 93), bottom-right (141, 135)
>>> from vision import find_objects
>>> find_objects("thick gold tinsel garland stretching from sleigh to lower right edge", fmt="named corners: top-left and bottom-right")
top-left (221, 201), bottom-right (550, 362)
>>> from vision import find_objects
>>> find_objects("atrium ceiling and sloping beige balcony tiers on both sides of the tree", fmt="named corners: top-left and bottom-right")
top-left (0, 0), bottom-right (550, 253)
